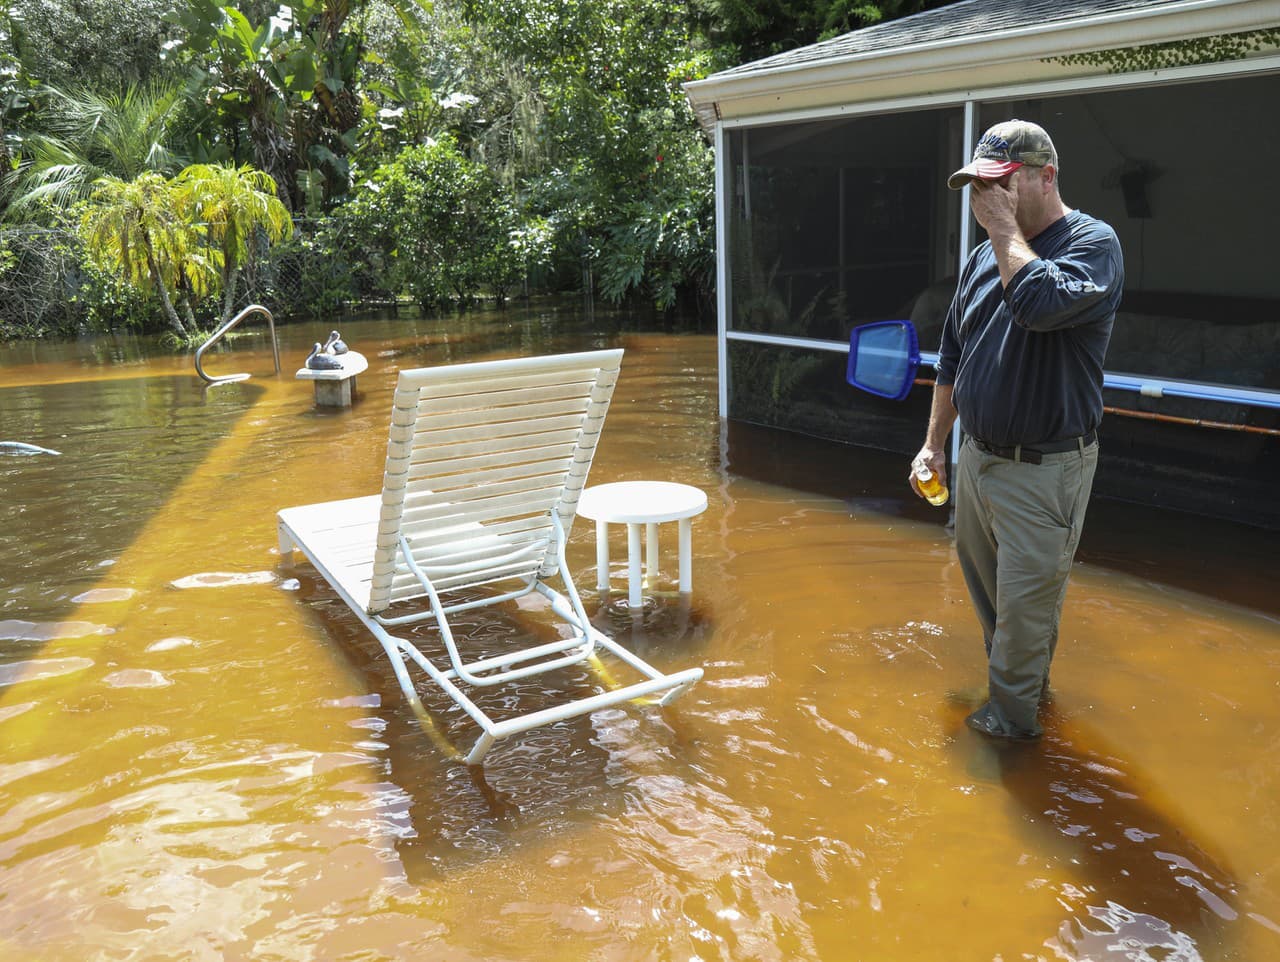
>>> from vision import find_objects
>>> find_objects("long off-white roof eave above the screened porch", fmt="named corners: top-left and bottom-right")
top-left (684, 0), bottom-right (1280, 129)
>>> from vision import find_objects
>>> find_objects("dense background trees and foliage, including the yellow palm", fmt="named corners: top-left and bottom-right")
top-left (0, 0), bottom-right (962, 329)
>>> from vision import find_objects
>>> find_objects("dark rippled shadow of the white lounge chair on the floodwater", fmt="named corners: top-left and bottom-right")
top-left (298, 569), bottom-right (712, 884)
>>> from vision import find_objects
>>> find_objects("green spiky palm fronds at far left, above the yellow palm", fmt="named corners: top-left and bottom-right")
top-left (5, 84), bottom-right (182, 219)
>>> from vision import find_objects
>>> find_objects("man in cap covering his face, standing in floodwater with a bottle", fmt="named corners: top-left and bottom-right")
top-left (910, 120), bottom-right (1124, 738)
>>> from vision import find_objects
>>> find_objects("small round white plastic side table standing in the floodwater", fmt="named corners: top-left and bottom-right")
top-left (577, 481), bottom-right (707, 608)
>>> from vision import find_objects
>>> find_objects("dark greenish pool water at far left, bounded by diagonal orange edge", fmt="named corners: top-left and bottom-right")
top-left (0, 375), bottom-right (262, 619)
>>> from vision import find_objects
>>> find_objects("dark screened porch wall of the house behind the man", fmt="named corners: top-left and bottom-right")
top-left (722, 73), bottom-right (1280, 528)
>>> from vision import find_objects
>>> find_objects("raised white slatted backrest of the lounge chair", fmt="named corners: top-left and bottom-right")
top-left (369, 351), bottom-right (622, 613)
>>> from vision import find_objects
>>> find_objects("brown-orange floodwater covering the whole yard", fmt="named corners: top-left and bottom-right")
top-left (0, 306), bottom-right (1280, 962)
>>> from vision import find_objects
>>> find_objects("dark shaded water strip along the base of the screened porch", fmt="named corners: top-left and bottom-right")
top-left (727, 421), bottom-right (1280, 615)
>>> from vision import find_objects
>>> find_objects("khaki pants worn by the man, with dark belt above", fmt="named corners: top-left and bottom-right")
top-left (955, 441), bottom-right (1098, 734)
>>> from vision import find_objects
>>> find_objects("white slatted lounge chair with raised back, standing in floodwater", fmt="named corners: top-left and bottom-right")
top-left (278, 351), bottom-right (703, 764)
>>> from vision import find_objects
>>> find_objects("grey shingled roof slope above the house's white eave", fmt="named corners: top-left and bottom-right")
top-left (714, 0), bottom-right (1185, 78)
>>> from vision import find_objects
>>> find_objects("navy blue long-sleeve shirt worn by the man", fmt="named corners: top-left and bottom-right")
top-left (937, 211), bottom-right (1124, 446)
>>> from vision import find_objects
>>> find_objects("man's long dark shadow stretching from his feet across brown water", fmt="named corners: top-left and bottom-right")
top-left (947, 700), bottom-right (1251, 962)
